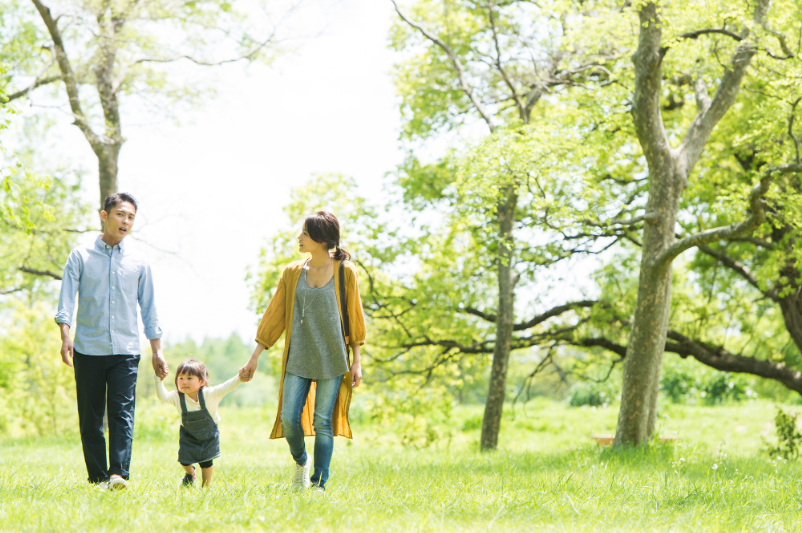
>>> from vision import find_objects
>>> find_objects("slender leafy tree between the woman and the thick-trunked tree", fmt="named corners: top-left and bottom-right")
top-left (388, 1), bottom-right (619, 449)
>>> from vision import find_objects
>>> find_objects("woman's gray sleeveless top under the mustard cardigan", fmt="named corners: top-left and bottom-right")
top-left (286, 269), bottom-right (348, 379)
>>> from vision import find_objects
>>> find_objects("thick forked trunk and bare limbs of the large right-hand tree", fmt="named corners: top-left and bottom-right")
top-left (616, 0), bottom-right (802, 445)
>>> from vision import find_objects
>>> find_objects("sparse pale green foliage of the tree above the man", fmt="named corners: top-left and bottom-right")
top-left (0, 0), bottom-right (278, 116)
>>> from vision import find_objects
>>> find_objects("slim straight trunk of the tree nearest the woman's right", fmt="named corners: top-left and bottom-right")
top-left (481, 185), bottom-right (518, 450)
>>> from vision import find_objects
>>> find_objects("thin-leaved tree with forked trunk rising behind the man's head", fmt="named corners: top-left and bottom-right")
top-left (0, 0), bottom-right (276, 212)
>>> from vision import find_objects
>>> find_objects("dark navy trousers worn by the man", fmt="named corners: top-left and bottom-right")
top-left (73, 352), bottom-right (139, 483)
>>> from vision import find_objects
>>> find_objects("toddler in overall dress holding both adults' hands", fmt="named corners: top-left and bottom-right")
top-left (154, 359), bottom-right (242, 487)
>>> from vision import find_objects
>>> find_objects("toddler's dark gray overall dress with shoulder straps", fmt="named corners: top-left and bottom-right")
top-left (178, 388), bottom-right (220, 465)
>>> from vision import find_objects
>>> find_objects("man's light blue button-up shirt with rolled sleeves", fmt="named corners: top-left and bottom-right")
top-left (56, 237), bottom-right (162, 355)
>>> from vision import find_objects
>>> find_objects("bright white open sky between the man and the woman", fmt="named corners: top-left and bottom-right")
top-left (25, 0), bottom-right (402, 342)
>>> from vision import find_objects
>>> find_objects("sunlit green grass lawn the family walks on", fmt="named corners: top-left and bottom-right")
top-left (0, 401), bottom-right (802, 533)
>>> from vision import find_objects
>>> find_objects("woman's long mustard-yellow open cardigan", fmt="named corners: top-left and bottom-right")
top-left (256, 259), bottom-right (366, 439)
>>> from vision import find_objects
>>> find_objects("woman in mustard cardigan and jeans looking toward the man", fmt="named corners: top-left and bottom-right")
top-left (240, 211), bottom-right (366, 492)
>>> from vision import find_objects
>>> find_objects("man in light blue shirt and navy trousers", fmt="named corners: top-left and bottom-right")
top-left (56, 193), bottom-right (168, 490)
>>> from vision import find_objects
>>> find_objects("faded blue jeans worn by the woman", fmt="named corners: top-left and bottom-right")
top-left (281, 373), bottom-right (343, 488)
